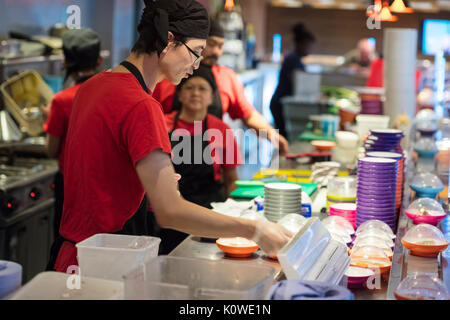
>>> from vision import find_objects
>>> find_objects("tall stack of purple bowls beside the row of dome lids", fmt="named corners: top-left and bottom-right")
top-left (356, 157), bottom-right (397, 230)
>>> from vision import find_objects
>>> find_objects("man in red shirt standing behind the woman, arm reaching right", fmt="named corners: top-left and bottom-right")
top-left (153, 20), bottom-right (289, 155)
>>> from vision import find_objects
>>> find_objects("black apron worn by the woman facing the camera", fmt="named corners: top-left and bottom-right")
top-left (159, 112), bottom-right (226, 255)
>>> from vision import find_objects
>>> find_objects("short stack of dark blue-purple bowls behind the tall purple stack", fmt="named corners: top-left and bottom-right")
top-left (364, 129), bottom-right (403, 153)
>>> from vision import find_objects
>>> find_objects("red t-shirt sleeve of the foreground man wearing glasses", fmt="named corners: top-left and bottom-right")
top-left (122, 100), bottom-right (171, 165)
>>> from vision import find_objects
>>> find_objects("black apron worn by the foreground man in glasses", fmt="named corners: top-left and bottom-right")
top-left (46, 61), bottom-right (150, 271)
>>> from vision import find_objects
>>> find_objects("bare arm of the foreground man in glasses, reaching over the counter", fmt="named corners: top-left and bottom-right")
top-left (136, 150), bottom-right (292, 254)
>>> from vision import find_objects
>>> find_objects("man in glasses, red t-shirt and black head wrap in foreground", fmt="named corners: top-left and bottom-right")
top-left (48, 0), bottom-right (292, 272)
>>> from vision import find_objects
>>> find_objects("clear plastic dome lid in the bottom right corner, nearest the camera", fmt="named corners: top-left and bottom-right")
top-left (394, 274), bottom-right (450, 300)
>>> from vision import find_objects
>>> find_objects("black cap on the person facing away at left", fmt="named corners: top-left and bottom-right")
top-left (63, 28), bottom-right (100, 79)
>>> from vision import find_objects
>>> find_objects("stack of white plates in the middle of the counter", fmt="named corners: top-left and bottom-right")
top-left (264, 182), bottom-right (302, 222)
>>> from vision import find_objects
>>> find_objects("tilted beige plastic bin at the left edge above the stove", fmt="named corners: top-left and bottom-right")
top-left (0, 70), bottom-right (54, 136)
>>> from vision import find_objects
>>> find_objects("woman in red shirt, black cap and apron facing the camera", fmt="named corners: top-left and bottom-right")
top-left (158, 66), bottom-right (242, 254)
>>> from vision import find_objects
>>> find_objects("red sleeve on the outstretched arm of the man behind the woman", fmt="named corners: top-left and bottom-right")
top-left (223, 70), bottom-right (255, 120)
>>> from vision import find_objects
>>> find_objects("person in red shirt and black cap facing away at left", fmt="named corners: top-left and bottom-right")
top-left (44, 28), bottom-right (103, 237)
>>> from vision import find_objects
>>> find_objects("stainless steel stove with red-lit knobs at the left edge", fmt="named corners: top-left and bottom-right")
top-left (0, 158), bottom-right (58, 282)
